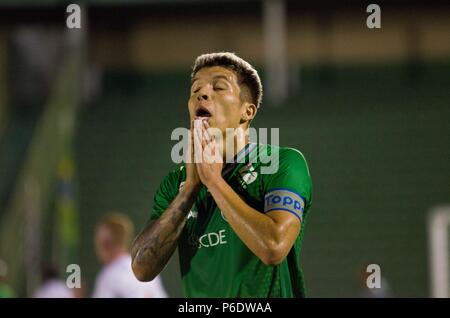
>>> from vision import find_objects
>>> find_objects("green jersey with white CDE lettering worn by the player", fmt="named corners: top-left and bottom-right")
top-left (151, 143), bottom-right (312, 298)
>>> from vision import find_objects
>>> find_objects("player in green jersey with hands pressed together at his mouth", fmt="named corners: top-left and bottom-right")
top-left (132, 53), bottom-right (312, 297)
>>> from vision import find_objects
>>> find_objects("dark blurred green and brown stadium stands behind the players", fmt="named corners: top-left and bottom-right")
top-left (0, 0), bottom-right (450, 297)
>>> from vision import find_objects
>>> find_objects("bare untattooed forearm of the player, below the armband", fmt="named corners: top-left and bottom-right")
top-left (208, 179), bottom-right (285, 265)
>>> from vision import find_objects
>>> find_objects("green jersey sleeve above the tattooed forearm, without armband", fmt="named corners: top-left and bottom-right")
top-left (150, 166), bottom-right (185, 220)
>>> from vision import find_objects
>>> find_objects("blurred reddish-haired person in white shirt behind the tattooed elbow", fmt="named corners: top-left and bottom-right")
top-left (92, 213), bottom-right (167, 298)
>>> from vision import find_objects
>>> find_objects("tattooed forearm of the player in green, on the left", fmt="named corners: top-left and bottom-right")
top-left (131, 185), bottom-right (199, 281)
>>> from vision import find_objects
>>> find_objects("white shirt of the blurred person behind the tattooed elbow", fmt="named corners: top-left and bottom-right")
top-left (92, 254), bottom-right (167, 298)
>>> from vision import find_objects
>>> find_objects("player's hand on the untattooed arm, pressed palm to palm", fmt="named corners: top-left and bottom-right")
top-left (194, 120), bottom-right (223, 187)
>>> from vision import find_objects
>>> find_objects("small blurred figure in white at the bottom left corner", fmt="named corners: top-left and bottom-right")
top-left (33, 265), bottom-right (74, 298)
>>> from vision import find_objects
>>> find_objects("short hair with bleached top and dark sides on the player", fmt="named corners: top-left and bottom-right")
top-left (191, 52), bottom-right (263, 108)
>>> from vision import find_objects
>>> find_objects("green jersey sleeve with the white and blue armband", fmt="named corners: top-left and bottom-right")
top-left (264, 148), bottom-right (312, 222)
